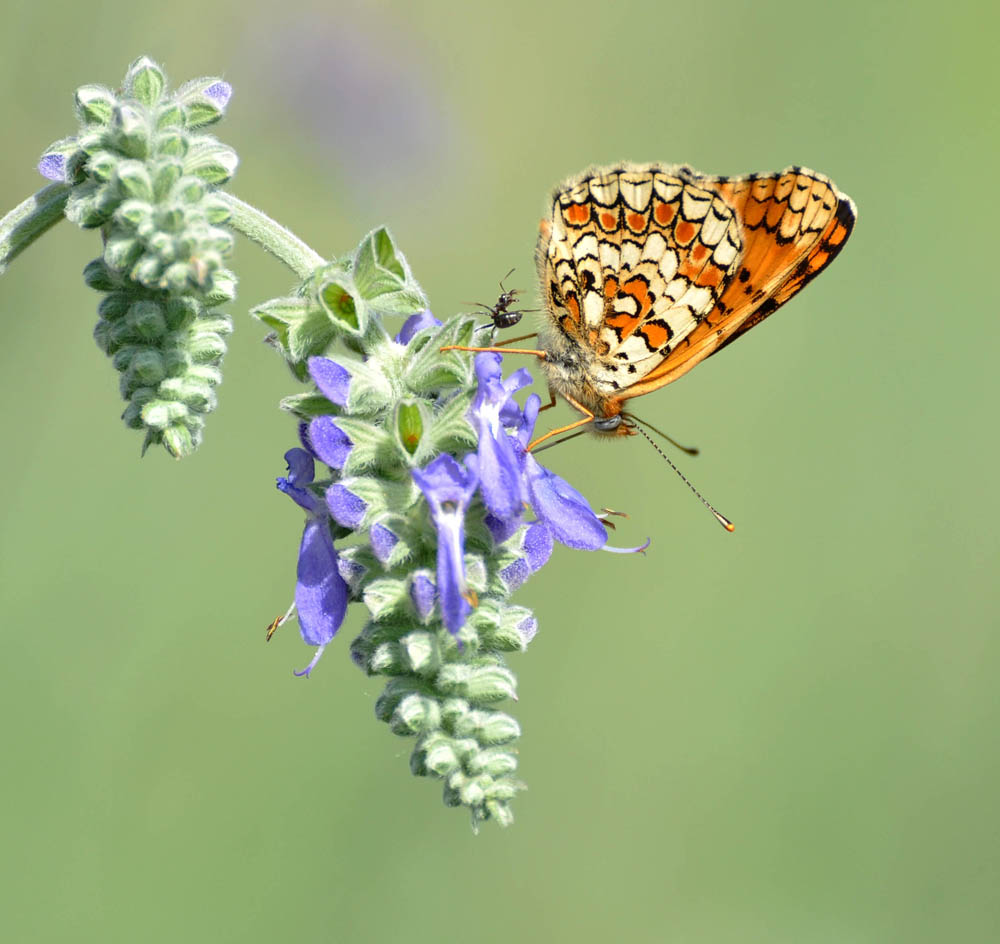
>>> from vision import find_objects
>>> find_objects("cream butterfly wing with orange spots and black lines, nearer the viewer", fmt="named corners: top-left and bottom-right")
top-left (539, 165), bottom-right (740, 395)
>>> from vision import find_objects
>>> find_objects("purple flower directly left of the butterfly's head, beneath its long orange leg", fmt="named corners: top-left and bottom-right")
top-left (469, 353), bottom-right (531, 520)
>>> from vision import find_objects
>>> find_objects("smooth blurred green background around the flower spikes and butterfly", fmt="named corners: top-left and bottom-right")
top-left (0, 0), bottom-right (1000, 944)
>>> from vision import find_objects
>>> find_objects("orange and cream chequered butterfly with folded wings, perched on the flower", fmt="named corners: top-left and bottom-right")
top-left (536, 164), bottom-right (855, 435)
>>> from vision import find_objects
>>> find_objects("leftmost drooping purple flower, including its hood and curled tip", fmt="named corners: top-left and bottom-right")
top-left (278, 449), bottom-right (348, 677)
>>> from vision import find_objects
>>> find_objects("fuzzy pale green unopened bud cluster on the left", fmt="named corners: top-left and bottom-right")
top-left (39, 58), bottom-right (237, 457)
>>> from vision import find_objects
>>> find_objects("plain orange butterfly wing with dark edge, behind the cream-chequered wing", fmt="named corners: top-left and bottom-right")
top-left (618, 167), bottom-right (857, 400)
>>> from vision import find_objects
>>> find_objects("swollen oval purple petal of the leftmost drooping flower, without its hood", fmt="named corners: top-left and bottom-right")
top-left (295, 518), bottom-right (347, 646)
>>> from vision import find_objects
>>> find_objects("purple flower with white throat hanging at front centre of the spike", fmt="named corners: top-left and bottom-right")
top-left (411, 455), bottom-right (479, 634)
